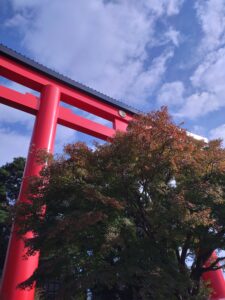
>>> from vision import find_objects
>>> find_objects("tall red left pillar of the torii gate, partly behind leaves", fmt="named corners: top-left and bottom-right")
top-left (0, 85), bottom-right (60, 300)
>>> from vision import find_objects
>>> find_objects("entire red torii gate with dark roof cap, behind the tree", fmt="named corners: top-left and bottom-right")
top-left (0, 45), bottom-right (225, 300)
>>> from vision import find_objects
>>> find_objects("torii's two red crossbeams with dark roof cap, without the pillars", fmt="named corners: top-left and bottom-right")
top-left (0, 44), bottom-right (139, 140)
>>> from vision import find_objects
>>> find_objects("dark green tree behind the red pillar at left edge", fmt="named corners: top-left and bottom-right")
top-left (0, 157), bottom-right (25, 270)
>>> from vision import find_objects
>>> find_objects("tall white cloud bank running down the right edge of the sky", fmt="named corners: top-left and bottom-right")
top-left (172, 0), bottom-right (225, 119)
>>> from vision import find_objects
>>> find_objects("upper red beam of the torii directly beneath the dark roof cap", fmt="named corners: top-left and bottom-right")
top-left (0, 55), bottom-right (132, 123)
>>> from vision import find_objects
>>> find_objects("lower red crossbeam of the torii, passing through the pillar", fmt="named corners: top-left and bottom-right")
top-left (0, 86), bottom-right (115, 140)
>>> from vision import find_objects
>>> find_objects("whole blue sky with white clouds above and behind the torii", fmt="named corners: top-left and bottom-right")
top-left (0, 0), bottom-right (225, 165)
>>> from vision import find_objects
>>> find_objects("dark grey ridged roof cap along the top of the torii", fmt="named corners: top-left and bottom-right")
top-left (0, 44), bottom-right (140, 114)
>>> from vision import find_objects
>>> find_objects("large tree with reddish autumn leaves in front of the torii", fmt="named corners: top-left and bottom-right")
top-left (18, 108), bottom-right (225, 299)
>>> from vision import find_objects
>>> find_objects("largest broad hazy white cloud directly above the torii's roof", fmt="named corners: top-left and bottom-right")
top-left (4, 0), bottom-right (183, 105)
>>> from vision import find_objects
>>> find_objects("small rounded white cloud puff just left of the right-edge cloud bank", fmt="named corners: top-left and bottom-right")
top-left (157, 81), bottom-right (184, 106)
